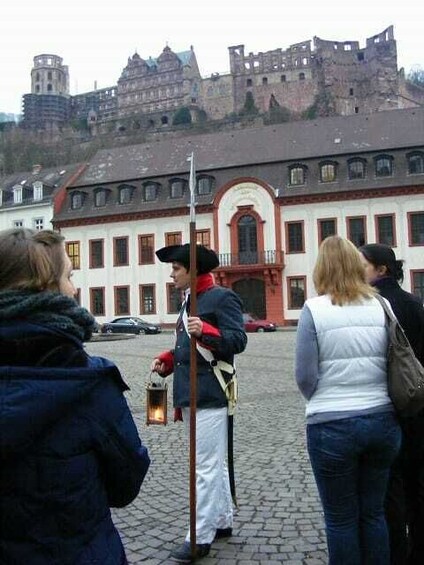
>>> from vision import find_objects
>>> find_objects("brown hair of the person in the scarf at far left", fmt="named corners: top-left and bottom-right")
top-left (0, 228), bottom-right (65, 291)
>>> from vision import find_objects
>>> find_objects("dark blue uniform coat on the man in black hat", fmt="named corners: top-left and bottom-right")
top-left (173, 286), bottom-right (247, 408)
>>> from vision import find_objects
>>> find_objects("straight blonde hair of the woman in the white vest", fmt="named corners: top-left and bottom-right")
top-left (313, 235), bottom-right (375, 306)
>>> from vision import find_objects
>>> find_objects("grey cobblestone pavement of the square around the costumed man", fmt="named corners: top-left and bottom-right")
top-left (88, 331), bottom-right (327, 565)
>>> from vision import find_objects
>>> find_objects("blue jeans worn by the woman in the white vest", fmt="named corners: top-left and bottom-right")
top-left (307, 412), bottom-right (401, 565)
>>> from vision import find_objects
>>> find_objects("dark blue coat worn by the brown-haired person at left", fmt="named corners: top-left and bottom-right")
top-left (0, 323), bottom-right (149, 565)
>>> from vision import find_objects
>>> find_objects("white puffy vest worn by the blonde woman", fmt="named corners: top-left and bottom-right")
top-left (306, 296), bottom-right (390, 416)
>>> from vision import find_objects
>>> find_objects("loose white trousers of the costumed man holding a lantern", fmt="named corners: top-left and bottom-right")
top-left (183, 407), bottom-right (233, 544)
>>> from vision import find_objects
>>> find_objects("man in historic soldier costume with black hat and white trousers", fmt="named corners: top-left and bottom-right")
top-left (152, 244), bottom-right (247, 563)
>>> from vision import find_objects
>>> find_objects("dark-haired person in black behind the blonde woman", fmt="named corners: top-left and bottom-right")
top-left (359, 244), bottom-right (424, 565)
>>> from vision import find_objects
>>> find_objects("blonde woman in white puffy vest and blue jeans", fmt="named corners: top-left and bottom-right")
top-left (296, 236), bottom-right (401, 565)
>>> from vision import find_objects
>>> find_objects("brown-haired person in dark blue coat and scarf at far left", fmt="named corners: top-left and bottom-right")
top-left (0, 229), bottom-right (150, 565)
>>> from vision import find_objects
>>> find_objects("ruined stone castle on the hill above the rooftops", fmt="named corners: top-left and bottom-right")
top-left (24, 26), bottom-right (424, 129)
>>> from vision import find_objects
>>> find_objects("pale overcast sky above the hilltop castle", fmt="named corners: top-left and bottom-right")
top-left (0, 0), bottom-right (424, 113)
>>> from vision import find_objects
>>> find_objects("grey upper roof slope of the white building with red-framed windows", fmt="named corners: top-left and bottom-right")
top-left (74, 108), bottom-right (424, 186)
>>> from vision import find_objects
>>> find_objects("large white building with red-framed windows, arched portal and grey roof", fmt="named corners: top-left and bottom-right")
top-left (53, 108), bottom-right (424, 325)
